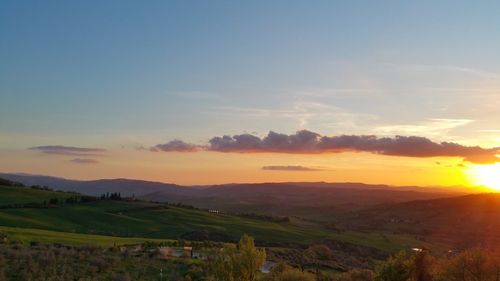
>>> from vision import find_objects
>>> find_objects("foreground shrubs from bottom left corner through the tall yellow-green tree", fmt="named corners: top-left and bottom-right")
top-left (0, 235), bottom-right (266, 281)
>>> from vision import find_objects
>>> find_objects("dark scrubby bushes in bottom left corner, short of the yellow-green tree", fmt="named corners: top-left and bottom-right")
top-left (0, 241), bottom-right (197, 281)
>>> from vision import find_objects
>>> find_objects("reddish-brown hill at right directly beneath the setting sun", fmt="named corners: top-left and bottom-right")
top-left (340, 193), bottom-right (500, 248)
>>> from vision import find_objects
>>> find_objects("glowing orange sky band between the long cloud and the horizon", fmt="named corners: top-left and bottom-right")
top-left (0, 149), bottom-right (476, 186)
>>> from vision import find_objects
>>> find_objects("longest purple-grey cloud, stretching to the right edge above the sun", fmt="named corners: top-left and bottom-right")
top-left (152, 130), bottom-right (500, 164)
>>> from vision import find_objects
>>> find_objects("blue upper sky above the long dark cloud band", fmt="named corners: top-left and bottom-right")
top-left (0, 1), bottom-right (500, 185)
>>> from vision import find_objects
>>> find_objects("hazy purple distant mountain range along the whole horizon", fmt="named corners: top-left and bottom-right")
top-left (0, 173), bottom-right (476, 217)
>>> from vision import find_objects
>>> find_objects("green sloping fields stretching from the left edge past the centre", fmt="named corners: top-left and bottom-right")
top-left (0, 184), bottom-right (428, 252)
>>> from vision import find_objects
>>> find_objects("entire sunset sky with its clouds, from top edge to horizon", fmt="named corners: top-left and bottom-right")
top-left (0, 0), bottom-right (500, 186)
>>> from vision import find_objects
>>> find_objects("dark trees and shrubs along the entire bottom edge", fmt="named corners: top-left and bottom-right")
top-left (0, 232), bottom-right (500, 281)
